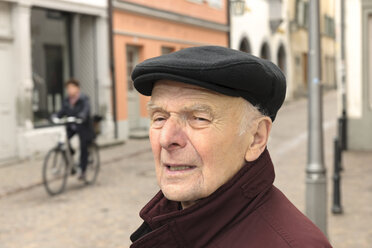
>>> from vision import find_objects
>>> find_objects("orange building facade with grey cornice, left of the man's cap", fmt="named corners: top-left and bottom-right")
top-left (112, 0), bottom-right (229, 139)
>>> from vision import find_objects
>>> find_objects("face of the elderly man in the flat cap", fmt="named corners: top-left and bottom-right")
top-left (149, 80), bottom-right (252, 207)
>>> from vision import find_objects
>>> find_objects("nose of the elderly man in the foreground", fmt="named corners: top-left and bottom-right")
top-left (160, 116), bottom-right (187, 151)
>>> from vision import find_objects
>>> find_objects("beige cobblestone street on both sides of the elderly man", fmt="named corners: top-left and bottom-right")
top-left (0, 92), bottom-right (372, 248)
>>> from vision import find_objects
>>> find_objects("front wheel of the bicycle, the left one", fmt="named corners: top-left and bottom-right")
top-left (43, 148), bottom-right (68, 195)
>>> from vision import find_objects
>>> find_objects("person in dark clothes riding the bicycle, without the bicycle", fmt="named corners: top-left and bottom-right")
top-left (57, 78), bottom-right (94, 180)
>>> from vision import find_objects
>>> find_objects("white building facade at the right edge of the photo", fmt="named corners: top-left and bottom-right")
top-left (337, 0), bottom-right (372, 151)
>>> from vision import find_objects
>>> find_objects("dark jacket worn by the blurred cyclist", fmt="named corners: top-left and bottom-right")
top-left (57, 93), bottom-right (94, 140)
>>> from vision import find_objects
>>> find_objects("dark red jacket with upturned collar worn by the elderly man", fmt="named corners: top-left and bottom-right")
top-left (131, 150), bottom-right (331, 248)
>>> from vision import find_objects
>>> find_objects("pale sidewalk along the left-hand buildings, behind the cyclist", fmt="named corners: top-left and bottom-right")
top-left (0, 140), bottom-right (151, 199)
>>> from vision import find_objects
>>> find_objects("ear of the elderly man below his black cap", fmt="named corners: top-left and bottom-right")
top-left (245, 116), bottom-right (272, 162)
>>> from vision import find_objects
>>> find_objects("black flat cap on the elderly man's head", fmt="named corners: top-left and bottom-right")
top-left (132, 46), bottom-right (286, 121)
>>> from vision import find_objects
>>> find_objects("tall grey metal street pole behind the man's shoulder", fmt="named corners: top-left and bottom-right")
top-left (306, 0), bottom-right (327, 236)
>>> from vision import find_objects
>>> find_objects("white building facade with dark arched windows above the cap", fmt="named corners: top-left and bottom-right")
top-left (230, 0), bottom-right (292, 97)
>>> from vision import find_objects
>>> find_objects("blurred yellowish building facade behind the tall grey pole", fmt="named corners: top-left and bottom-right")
top-left (287, 0), bottom-right (337, 96)
